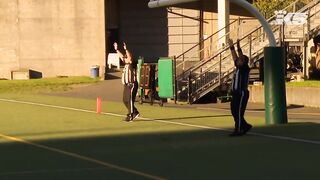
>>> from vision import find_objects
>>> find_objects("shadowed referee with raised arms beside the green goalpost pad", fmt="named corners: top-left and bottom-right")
top-left (229, 39), bottom-right (252, 136)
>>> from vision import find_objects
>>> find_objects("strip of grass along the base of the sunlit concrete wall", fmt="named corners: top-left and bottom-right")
top-left (0, 76), bottom-right (99, 93)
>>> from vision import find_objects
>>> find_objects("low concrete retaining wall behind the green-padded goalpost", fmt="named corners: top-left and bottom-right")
top-left (249, 85), bottom-right (320, 108)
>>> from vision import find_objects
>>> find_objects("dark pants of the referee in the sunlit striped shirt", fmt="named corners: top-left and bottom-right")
top-left (123, 82), bottom-right (138, 115)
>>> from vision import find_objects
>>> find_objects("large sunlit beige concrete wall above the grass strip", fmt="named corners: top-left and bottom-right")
top-left (0, 0), bottom-right (105, 79)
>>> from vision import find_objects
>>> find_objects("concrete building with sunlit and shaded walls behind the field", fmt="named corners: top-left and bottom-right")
top-left (0, 0), bottom-right (255, 79)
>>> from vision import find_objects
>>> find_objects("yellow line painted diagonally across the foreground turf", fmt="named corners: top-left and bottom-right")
top-left (0, 134), bottom-right (164, 180)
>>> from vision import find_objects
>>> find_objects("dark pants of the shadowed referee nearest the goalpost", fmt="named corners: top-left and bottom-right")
top-left (230, 90), bottom-right (249, 132)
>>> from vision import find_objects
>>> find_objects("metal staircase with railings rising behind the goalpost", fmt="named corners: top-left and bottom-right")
top-left (176, 0), bottom-right (320, 104)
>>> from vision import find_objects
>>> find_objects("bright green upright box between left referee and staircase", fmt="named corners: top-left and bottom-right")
top-left (158, 58), bottom-right (174, 98)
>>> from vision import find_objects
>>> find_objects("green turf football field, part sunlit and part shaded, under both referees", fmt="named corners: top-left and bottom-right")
top-left (0, 94), bottom-right (320, 180)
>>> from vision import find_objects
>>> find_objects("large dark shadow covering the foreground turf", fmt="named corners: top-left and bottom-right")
top-left (0, 122), bottom-right (320, 180)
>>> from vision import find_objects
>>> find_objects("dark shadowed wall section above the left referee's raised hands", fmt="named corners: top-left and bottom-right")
top-left (117, 0), bottom-right (168, 62)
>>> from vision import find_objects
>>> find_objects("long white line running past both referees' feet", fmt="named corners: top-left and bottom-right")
top-left (0, 98), bottom-right (320, 145)
